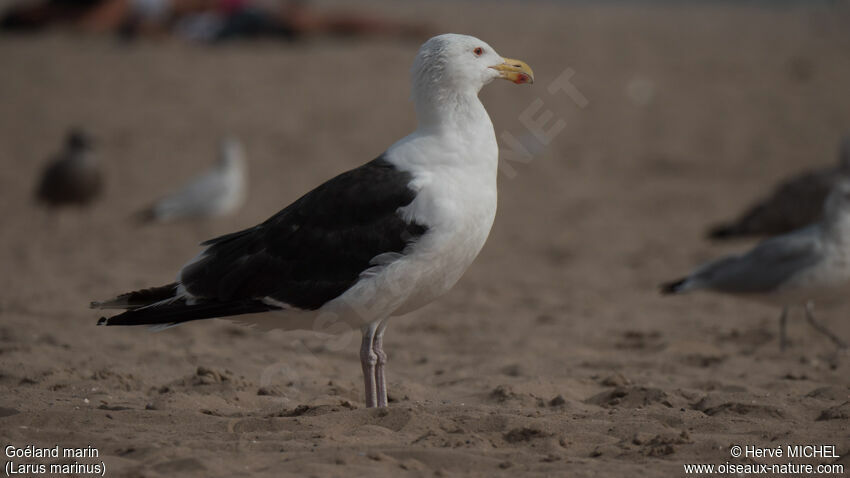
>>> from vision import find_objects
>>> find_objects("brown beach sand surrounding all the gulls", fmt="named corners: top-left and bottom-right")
top-left (0, 2), bottom-right (850, 477)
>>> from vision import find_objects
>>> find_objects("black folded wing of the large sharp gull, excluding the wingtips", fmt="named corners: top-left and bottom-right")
top-left (181, 155), bottom-right (427, 310)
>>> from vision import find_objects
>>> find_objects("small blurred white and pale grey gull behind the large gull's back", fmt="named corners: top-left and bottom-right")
top-left (138, 137), bottom-right (246, 222)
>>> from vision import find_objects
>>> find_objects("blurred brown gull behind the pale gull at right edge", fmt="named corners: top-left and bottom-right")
top-left (708, 136), bottom-right (850, 240)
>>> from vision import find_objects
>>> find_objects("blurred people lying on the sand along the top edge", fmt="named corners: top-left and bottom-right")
top-left (0, 0), bottom-right (428, 41)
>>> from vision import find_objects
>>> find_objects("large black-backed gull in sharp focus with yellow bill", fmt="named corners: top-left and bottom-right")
top-left (92, 34), bottom-right (533, 407)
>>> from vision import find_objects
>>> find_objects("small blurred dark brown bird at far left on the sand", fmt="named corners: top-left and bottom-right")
top-left (36, 129), bottom-right (103, 208)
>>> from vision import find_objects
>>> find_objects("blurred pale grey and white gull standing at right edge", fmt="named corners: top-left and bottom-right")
top-left (661, 181), bottom-right (850, 349)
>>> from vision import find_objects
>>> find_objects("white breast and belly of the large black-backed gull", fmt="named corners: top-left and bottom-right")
top-left (323, 120), bottom-right (498, 324)
